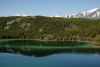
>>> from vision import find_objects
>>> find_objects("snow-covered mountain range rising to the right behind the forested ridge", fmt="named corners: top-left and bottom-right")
top-left (51, 8), bottom-right (100, 19)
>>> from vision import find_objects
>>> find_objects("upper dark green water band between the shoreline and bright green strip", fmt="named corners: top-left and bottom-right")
top-left (0, 40), bottom-right (88, 47)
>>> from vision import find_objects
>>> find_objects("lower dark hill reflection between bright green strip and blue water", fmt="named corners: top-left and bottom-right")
top-left (0, 47), bottom-right (100, 57)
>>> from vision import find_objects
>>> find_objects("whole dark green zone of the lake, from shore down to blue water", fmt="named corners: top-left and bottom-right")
top-left (0, 40), bottom-right (100, 57)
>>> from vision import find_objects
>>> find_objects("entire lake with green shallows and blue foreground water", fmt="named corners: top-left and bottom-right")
top-left (0, 40), bottom-right (100, 67)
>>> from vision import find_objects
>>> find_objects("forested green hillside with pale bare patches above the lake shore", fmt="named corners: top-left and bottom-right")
top-left (0, 16), bottom-right (100, 42)
